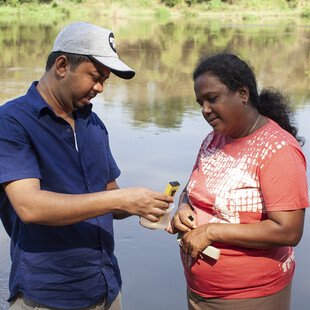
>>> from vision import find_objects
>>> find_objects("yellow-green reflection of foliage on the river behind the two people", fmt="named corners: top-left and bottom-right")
top-left (0, 11), bottom-right (310, 124)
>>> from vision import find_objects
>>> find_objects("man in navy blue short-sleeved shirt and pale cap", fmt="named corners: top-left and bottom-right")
top-left (0, 22), bottom-right (172, 310)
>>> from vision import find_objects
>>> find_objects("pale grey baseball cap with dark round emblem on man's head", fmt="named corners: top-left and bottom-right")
top-left (52, 22), bottom-right (135, 79)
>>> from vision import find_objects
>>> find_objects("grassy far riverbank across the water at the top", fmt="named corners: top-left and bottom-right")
top-left (0, 0), bottom-right (310, 21)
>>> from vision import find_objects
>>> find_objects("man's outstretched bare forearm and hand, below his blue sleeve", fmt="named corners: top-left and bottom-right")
top-left (4, 179), bottom-right (171, 226)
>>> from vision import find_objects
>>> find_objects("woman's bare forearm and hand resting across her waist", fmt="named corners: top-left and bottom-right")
top-left (182, 209), bottom-right (305, 258)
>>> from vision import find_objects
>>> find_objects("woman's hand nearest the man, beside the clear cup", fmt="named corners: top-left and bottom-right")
top-left (166, 203), bottom-right (197, 234)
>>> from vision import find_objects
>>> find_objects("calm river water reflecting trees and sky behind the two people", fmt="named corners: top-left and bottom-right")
top-left (0, 13), bottom-right (310, 310)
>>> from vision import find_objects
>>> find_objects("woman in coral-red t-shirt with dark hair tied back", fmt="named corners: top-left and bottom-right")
top-left (168, 53), bottom-right (309, 310)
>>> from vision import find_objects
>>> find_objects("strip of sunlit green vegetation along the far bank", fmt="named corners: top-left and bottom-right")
top-left (0, 0), bottom-right (310, 19)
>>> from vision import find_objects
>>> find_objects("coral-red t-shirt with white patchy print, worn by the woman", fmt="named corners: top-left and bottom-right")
top-left (185, 120), bottom-right (309, 299)
